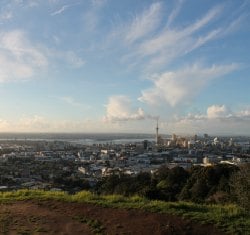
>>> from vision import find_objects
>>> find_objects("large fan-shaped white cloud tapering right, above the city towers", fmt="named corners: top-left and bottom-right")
top-left (139, 64), bottom-right (239, 106)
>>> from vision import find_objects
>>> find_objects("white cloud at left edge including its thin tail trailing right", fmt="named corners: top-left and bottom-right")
top-left (0, 30), bottom-right (85, 82)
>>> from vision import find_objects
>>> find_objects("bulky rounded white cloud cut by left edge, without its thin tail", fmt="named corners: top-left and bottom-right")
top-left (0, 30), bottom-right (48, 82)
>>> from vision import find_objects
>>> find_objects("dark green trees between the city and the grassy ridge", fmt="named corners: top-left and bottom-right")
top-left (95, 164), bottom-right (250, 209)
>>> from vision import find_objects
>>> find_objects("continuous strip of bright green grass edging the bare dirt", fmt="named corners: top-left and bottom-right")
top-left (0, 190), bottom-right (250, 234)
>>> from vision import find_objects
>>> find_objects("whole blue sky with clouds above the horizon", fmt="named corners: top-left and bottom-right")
top-left (0, 0), bottom-right (250, 135)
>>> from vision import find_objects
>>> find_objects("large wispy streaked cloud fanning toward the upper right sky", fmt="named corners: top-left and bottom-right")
top-left (107, 0), bottom-right (243, 74)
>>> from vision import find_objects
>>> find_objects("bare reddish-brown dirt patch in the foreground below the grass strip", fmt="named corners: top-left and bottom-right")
top-left (0, 201), bottom-right (224, 235)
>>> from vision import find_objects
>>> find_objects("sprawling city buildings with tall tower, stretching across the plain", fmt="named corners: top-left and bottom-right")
top-left (0, 130), bottom-right (250, 192)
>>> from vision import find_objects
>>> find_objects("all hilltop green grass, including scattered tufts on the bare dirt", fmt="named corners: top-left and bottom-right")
top-left (0, 190), bottom-right (250, 234)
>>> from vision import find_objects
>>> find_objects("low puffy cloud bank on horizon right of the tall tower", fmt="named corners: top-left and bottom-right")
top-left (166, 105), bottom-right (250, 135)
